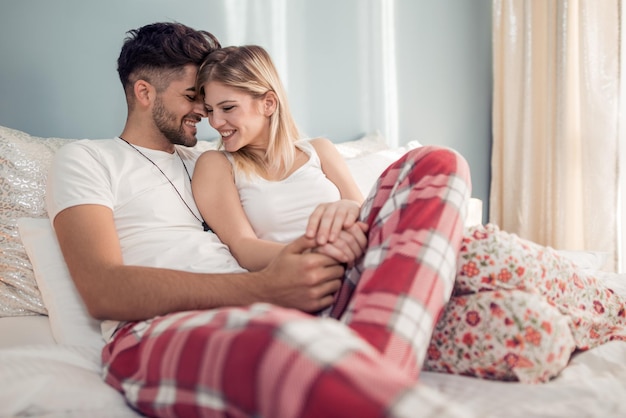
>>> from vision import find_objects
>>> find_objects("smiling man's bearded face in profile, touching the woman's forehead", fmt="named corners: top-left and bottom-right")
top-left (152, 65), bottom-right (206, 147)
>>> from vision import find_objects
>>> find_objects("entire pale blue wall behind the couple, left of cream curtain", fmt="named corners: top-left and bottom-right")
top-left (0, 0), bottom-right (492, 216)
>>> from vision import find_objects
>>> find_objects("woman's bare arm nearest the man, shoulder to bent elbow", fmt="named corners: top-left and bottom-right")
top-left (191, 151), bottom-right (284, 271)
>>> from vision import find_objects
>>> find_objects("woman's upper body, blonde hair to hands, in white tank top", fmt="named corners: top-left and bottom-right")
top-left (192, 46), bottom-right (365, 270)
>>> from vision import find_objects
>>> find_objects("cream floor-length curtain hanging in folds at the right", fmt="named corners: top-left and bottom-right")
top-left (489, 0), bottom-right (620, 270)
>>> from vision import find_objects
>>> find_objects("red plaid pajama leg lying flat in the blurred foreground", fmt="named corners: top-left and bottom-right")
top-left (103, 304), bottom-right (458, 418)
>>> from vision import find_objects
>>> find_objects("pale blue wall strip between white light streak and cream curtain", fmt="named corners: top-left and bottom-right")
top-left (396, 0), bottom-right (493, 207)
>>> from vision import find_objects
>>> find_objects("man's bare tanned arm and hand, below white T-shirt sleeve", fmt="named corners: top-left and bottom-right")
top-left (54, 205), bottom-right (343, 320)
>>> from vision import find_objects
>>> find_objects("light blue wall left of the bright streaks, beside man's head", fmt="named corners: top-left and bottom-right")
top-left (0, 0), bottom-right (228, 138)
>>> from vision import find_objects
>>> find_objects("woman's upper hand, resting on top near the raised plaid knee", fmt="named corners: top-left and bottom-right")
top-left (305, 199), bottom-right (361, 246)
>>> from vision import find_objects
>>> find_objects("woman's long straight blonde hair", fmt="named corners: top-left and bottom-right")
top-left (196, 45), bottom-right (300, 174)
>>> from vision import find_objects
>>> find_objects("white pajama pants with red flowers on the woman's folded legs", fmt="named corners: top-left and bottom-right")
top-left (425, 224), bottom-right (626, 383)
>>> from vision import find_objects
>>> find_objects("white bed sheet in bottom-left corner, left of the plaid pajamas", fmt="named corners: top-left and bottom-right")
top-left (0, 316), bottom-right (140, 418)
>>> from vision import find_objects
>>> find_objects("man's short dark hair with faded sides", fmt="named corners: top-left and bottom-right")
top-left (117, 22), bottom-right (220, 96)
